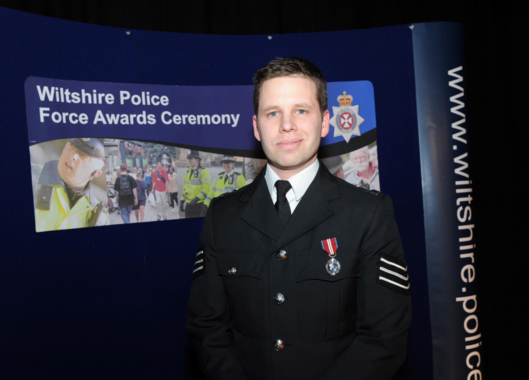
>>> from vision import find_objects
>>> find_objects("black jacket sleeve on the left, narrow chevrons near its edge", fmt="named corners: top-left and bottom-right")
top-left (187, 202), bottom-right (247, 380)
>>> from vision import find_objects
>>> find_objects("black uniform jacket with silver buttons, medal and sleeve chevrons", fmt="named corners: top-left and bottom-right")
top-left (187, 163), bottom-right (411, 380)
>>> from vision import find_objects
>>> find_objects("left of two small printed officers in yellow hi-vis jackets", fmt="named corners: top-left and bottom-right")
top-left (180, 150), bottom-right (211, 218)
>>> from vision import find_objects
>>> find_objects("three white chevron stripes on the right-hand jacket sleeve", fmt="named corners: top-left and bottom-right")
top-left (377, 253), bottom-right (410, 294)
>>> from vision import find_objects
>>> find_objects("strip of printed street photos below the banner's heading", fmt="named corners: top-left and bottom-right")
top-left (30, 138), bottom-right (380, 232)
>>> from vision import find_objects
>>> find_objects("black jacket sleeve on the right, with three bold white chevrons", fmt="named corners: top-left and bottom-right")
top-left (323, 194), bottom-right (411, 380)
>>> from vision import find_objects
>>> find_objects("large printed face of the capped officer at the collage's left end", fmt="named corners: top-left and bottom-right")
top-left (57, 142), bottom-right (104, 187)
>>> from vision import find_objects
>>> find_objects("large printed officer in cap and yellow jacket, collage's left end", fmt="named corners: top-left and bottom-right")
top-left (35, 138), bottom-right (109, 232)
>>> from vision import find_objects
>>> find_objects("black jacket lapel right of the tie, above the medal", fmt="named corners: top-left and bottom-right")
top-left (273, 162), bottom-right (340, 250)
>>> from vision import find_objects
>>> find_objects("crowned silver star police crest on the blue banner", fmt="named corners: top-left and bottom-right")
top-left (330, 91), bottom-right (364, 142)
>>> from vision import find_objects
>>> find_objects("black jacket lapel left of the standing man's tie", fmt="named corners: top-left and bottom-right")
top-left (240, 166), bottom-right (282, 241)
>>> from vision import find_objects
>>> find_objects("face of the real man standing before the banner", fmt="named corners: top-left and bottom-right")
top-left (253, 77), bottom-right (329, 179)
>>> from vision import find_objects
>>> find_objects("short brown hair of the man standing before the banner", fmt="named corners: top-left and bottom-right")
top-left (253, 57), bottom-right (327, 115)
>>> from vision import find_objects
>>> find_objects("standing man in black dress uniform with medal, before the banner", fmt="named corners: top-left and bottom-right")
top-left (187, 58), bottom-right (411, 380)
